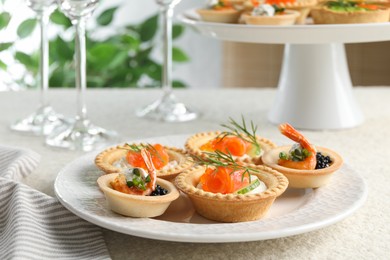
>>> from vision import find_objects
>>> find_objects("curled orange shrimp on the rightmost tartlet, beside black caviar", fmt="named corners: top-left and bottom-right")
top-left (278, 123), bottom-right (317, 170)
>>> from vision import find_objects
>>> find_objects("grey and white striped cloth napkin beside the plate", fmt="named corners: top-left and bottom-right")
top-left (0, 146), bottom-right (110, 259)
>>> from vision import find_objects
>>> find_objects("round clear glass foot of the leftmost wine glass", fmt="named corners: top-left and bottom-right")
top-left (10, 106), bottom-right (69, 135)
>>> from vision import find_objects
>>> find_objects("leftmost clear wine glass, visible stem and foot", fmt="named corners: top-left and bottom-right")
top-left (10, 0), bottom-right (68, 135)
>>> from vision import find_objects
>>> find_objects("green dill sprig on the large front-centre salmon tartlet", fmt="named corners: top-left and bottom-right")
top-left (192, 150), bottom-right (258, 182)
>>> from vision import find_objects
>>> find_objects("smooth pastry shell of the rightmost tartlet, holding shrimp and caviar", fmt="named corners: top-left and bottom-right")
top-left (262, 146), bottom-right (343, 188)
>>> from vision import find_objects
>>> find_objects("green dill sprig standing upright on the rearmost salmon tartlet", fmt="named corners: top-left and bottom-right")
top-left (220, 115), bottom-right (260, 150)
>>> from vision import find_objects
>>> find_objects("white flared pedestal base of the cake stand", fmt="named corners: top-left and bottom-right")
top-left (268, 43), bottom-right (363, 130)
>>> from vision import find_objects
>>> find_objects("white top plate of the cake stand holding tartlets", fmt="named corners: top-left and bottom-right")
top-left (178, 9), bottom-right (390, 44)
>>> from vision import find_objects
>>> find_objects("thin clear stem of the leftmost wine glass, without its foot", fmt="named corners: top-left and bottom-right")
top-left (38, 11), bottom-right (50, 107)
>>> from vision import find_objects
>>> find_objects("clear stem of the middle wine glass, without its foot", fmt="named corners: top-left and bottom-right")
top-left (72, 18), bottom-right (87, 121)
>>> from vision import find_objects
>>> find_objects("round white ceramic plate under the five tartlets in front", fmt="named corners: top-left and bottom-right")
top-left (54, 135), bottom-right (367, 243)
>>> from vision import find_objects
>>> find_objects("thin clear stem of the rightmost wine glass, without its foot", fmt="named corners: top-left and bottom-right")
top-left (161, 6), bottom-right (173, 96)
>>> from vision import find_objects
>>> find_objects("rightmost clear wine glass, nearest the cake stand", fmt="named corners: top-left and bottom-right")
top-left (136, 0), bottom-right (197, 122)
